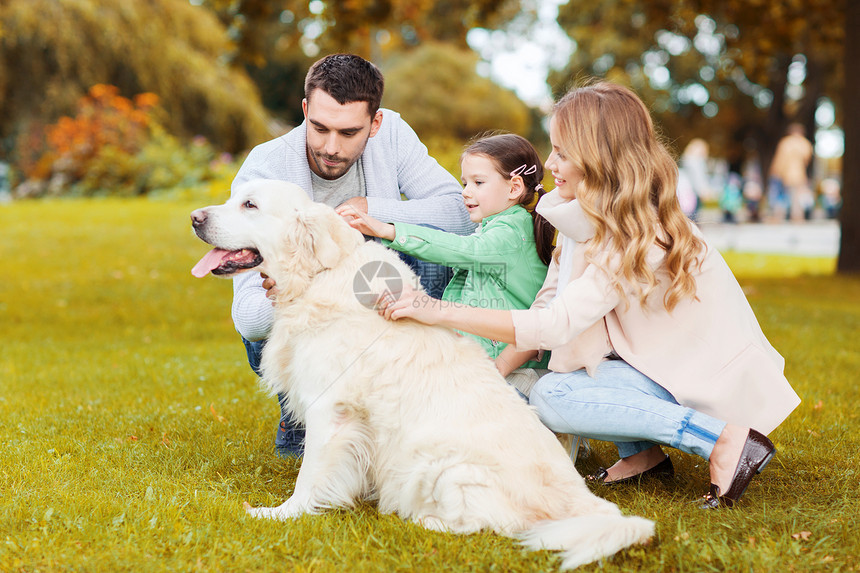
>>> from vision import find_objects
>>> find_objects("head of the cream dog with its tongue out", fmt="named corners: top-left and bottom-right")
top-left (191, 179), bottom-right (364, 298)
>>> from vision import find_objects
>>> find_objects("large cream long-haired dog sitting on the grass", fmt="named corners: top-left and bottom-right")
top-left (191, 180), bottom-right (654, 568)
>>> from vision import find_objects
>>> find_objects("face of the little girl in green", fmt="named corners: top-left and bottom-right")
top-left (460, 153), bottom-right (522, 223)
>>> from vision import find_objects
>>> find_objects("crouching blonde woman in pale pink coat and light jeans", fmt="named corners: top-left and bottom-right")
top-left (380, 83), bottom-right (800, 508)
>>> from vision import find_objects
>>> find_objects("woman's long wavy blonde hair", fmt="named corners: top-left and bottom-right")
top-left (553, 82), bottom-right (704, 311)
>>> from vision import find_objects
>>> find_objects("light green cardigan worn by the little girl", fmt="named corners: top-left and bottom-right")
top-left (382, 205), bottom-right (549, 368)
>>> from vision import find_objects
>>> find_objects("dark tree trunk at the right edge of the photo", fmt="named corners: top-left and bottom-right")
top-left (836, 0), bottom-right (860, 273)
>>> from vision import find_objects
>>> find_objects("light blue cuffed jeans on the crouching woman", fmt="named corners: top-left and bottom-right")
top-left (529, 360), bottom-right (726, 460)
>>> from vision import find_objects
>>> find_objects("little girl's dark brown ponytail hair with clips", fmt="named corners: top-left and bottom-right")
top-left (461, 133), bottom-right (555, 265)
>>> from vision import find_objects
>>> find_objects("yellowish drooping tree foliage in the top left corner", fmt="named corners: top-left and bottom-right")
top-left (0, 0), bottom-right (268, 153)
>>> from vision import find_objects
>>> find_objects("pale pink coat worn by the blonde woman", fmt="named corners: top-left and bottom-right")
top-left (512, 192), bottom-right (800, 434)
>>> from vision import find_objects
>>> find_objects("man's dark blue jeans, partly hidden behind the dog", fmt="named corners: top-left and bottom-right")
top-left (242, 248), bottom-right (453, 455)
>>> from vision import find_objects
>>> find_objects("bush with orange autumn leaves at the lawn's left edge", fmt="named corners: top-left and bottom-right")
top-left (16, 84), bottom-right (237, 197)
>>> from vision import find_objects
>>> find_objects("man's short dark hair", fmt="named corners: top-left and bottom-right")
top-left (305, 54), bottom-right (385, 117)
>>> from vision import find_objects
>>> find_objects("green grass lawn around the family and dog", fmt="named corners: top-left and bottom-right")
top-left (0, 200), bottom-right (860, 572)
